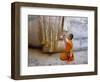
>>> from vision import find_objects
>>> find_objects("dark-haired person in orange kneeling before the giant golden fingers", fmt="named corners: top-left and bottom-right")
top-left (60, 34), bottom-right (74, 63)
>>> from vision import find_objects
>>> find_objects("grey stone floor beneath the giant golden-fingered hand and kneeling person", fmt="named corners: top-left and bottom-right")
top-left (28, 48), bottom-right (88, 66)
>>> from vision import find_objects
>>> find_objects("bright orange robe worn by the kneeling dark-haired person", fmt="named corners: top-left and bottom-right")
top-left (60, 40), bottom-right (74, 62)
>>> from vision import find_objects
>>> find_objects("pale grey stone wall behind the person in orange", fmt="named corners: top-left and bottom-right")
top-left (64, 17), bottom-right (88, 50)
